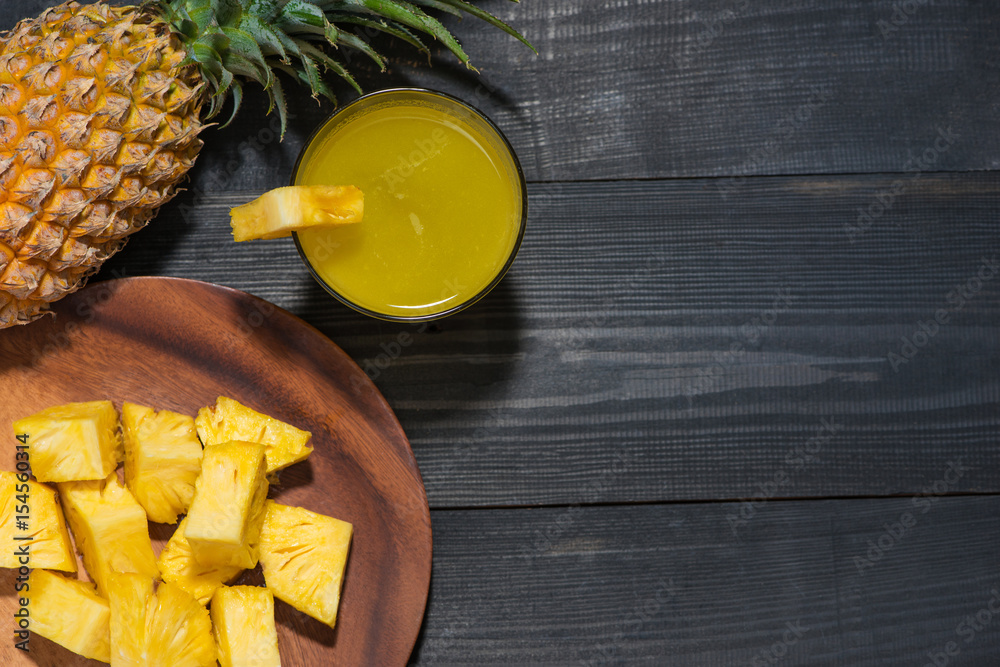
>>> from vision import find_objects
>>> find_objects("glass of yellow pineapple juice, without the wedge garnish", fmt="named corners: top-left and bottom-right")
top-left (292, 88), bottom-right (527, 321)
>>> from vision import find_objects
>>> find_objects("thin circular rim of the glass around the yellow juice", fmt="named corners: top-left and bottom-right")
top-left (290, 87), bottom-right (528, 322)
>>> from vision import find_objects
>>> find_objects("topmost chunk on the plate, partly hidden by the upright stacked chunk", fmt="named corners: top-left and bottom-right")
top-left (195, 396), bottom-right (312, 474)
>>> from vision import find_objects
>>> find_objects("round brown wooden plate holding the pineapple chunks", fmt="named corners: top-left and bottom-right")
top-left (0, 278), bottom-right (431, 667)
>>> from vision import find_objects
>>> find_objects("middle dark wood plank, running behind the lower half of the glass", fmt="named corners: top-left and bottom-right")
top-left (95, 173), bottom-right (1000, 507)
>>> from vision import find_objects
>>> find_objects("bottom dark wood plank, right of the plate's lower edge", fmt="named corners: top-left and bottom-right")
top-left (411, 498), bottom-right (1000, 666)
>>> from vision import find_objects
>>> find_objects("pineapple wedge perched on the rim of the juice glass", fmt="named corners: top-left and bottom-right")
top-left (229, 185), bottom-right (365, 241)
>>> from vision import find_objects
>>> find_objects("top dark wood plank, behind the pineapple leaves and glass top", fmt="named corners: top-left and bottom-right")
top-left (0, 0), bottom-right (1000, 183)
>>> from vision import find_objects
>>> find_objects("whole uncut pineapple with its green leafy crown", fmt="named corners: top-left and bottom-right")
top-left (0, 0), bottom-right (530, 328)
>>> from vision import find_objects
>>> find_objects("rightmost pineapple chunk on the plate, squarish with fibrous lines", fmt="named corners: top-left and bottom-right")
top-left (260, 500), bottom-right (354, 628)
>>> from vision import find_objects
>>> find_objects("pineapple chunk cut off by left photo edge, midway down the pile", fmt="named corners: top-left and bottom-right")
top-left (0, 472), bottom-right (76, 572)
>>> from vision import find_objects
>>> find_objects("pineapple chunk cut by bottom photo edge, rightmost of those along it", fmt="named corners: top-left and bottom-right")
top-left (212, 586), bottom-right (281, 667)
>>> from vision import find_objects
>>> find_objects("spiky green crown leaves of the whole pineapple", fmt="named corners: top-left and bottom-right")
top-left (148, 0), bottom-right (537, 136)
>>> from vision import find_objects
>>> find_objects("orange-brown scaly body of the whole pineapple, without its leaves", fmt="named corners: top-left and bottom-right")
top-left (0, 2), bottom-right (205, 328)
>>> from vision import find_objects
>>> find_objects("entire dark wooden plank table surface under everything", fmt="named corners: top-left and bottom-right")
top-left (2, 0), bottom-right (1000, 666)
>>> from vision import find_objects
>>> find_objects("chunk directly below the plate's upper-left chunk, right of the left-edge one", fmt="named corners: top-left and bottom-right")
top-left (59, 472), bottom-right (159, 596)
